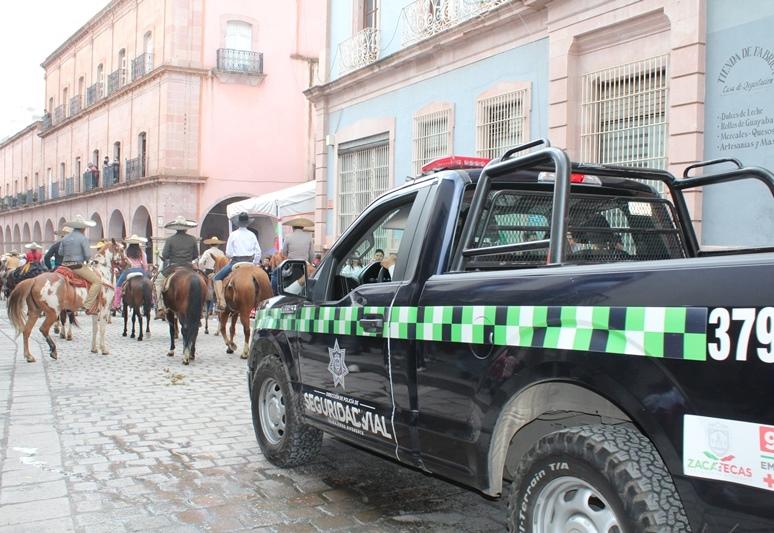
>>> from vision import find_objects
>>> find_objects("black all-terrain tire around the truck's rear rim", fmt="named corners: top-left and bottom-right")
top-left (507, 424), bottom-right (691, 533)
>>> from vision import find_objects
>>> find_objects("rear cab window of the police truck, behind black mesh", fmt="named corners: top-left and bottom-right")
top-left (461, 189), bottom-right (684, 271)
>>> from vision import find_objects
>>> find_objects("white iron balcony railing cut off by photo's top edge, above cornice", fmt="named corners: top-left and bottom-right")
top-left (401, 0), bottom-right (511, 46)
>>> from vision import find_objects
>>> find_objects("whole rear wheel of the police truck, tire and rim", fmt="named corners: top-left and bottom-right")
top-left (508, 424), bottom-right (690, 533)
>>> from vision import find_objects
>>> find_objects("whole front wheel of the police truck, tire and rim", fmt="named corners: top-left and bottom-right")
top-left (250, 357), bottom-right (322, 468)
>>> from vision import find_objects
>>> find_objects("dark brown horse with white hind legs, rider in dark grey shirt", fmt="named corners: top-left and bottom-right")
top-left (161, 268), bottom-right (207, 365)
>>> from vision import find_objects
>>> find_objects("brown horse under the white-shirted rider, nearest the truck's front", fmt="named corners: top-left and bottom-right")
top-left (219, 264), bottom-right (274, 359)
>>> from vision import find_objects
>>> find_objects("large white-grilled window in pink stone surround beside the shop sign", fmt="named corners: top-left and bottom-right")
top-left (581, 55), bottom-right (669, 186)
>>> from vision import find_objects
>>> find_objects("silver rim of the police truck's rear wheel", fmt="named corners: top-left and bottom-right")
top-left (532, 476), bottom-right (623, 533)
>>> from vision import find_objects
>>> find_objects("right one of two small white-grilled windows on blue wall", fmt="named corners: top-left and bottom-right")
top-left (476, 88), bottom-right (530, 159)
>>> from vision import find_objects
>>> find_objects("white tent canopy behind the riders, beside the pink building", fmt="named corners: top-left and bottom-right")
top-left (226, 181), bottom-right (315, 220)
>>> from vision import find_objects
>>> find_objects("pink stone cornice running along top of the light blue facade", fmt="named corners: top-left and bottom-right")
top-left (304, 0), bottom-right (546, 104)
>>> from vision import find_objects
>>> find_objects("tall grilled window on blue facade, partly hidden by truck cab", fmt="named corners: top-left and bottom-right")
top-left (337, 136), bottom-right (390, 233)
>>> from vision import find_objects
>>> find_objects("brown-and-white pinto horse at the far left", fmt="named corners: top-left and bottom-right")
top-left (8, 241), bottom-right (120, 363)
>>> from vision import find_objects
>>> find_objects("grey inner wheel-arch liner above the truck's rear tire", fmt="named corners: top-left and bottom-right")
top-left (483, 382), bottom-right (631, 496)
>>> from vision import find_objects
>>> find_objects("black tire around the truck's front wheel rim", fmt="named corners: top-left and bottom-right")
top-left (250, 357), bottom-right (323, 468)
